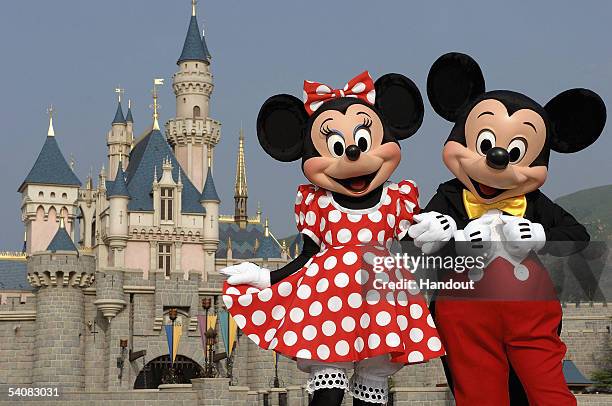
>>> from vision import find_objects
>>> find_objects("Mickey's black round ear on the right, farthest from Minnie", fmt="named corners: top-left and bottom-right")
top-left (544, 89), bottom-right (606, 154)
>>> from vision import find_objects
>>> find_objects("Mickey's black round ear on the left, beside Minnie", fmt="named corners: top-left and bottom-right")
top-left (427, 52), bottom-right (485, 122)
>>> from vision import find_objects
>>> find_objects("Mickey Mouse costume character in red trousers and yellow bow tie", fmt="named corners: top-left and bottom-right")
top-left (410, 53), bottom-right (606, 406)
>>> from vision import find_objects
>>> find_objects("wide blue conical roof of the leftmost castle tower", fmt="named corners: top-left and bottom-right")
top-left (19, 136), bottom-right (81, 192)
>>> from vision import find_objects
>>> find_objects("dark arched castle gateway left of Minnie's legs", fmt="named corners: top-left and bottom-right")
top-left (134, 354), bottom-right (204, 389)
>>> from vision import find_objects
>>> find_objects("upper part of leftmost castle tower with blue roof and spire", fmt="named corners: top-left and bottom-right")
top-left (18, 108), bottom-right (81, 255)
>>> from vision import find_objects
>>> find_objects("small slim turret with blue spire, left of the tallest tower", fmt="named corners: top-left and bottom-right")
top-left (106, 89), bottom-right (133, 180)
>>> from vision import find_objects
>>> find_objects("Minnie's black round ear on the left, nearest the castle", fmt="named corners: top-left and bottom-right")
top-left (257, 94), bottom-right (308, 162)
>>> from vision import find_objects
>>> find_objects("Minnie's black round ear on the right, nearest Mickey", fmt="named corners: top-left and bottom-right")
top-left (374, 73), bottom-right (425, 140)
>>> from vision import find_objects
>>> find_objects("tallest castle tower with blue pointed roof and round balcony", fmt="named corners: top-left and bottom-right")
top-left (165, 0), bottom-right (221, 191)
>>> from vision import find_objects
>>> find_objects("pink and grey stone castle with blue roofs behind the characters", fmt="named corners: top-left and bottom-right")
top-left (0, 1), bottom-right (612, 406)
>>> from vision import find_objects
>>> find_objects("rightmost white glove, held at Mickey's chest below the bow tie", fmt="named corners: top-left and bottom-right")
top-left (501, 215), bottom-right (546, 261)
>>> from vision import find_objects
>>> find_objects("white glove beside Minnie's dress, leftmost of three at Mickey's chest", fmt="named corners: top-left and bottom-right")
top-left (408, 211), bottom-right (457, 254)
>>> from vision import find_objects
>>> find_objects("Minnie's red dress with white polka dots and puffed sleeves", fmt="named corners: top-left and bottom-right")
top-left (223, 181), bottom-right (444, 364)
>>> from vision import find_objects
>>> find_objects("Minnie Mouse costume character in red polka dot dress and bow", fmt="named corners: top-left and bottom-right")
top-left (221, 72), bottom-right (452, 406)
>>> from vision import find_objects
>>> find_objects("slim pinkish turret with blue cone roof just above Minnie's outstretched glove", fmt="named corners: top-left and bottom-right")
top-left (200, 163), bottom-right (221, 272)
